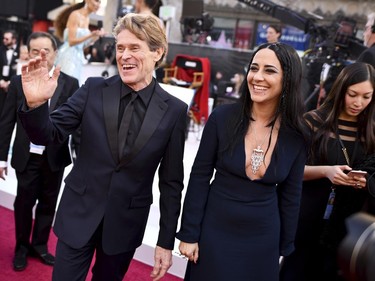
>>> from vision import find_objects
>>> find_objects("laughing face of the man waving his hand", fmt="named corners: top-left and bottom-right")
top-left (116, 29), bottom-right (163, 91)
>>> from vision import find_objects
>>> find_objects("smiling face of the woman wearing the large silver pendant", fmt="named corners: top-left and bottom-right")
top-left (247, 48), bottom-right (283, 104)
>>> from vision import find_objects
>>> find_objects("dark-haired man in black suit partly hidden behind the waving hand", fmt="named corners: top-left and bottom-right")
top-left (0, 32), bottom-right (79, 271)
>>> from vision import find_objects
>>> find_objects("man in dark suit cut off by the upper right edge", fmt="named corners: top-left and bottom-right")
top-left (357, 13), bottom-right (375, 67)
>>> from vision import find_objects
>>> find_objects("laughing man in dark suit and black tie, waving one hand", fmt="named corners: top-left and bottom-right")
top-left (19, 13), bottom-right (187, 281)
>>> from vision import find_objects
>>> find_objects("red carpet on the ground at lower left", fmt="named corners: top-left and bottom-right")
top-left (0, 206), bottom-right (182, 281)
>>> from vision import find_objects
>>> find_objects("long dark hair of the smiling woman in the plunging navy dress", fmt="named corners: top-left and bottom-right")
top-left (227, 43), bottom-right (306, 153)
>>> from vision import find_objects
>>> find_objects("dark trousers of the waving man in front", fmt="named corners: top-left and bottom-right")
top-left (52, 220), bottom-right (135, 281)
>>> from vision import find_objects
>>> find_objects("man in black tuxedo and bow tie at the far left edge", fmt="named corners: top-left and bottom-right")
top-left (0, 30), bottom-right (19, 115)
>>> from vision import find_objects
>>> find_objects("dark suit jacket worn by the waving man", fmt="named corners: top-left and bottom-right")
top-left (19, 75), bottom-right (187, 255)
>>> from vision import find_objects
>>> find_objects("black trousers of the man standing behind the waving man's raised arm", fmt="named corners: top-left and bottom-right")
top-left (14, 154), bottom-right (64, 253)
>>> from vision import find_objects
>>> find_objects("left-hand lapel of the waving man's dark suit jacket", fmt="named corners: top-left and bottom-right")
top-left (102, 79), bottom-right (122, 162)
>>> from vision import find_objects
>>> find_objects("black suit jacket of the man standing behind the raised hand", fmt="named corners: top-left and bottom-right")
top-left (0, 73), bottom-right (79, 172)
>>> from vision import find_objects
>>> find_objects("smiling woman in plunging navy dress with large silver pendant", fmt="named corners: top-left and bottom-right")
top-left (177, 43), bottom-right (306, 281)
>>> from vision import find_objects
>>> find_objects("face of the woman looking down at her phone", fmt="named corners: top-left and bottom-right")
top-left (340, 81), bottom-right (374, 121)
